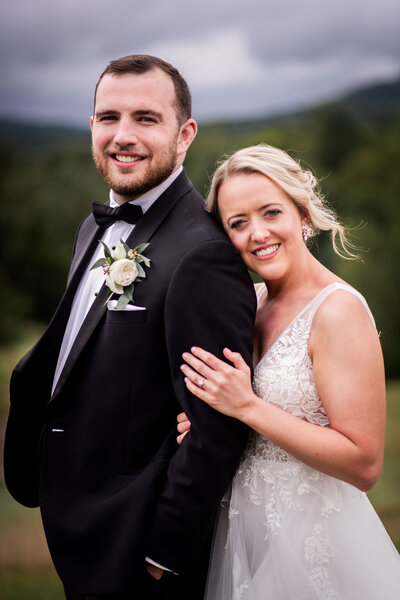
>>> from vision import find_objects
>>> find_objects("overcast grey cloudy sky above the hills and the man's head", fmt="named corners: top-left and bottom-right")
top-left (0, 0), bottom-right (400, 126)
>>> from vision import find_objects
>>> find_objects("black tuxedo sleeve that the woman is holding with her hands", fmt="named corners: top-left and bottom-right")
top-left (147, 240), bottom-right (256, 573)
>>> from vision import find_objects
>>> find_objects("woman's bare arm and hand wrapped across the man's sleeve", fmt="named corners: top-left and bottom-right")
top-left (182, 292), bottom-right (385, 490)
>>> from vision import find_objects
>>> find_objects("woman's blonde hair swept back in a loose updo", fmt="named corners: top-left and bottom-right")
top-left (206, 144), bottom-right (357, 258)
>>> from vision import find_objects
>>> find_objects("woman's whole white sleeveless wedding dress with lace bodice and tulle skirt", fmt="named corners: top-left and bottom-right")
top-left (206, 283), bottom-right (400, 600)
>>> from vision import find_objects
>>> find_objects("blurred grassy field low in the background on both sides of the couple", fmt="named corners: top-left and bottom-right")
top-left (0, 327), bottom-right (400, 600)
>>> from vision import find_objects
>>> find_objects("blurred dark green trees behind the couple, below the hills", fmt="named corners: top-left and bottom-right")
top-left (0, 83), bottom-right (400, 377)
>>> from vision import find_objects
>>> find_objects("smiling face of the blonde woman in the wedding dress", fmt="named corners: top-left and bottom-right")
top-left (218, 173), bottom-right (308, 281)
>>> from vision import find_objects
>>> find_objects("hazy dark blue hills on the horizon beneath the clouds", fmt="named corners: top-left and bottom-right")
top-left (0, 77), bottom-right (400, 148)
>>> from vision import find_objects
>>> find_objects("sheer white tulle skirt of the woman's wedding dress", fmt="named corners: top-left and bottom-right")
top-left (206, 459), bottom-right (400, 600)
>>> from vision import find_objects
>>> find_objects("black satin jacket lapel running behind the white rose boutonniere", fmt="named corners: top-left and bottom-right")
top-left (50, 171), bottom-right (193, 402)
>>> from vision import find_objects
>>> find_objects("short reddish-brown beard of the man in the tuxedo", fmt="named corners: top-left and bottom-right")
top-left (92, 137), bottom-right (178, 200)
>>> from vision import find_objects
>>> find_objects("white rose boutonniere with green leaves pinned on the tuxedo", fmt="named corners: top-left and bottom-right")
top-left (90, 240), bottom-right (150, 310)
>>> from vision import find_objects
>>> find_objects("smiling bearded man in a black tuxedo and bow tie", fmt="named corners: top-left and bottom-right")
top-left (5, 55), bottom-right (255, 600)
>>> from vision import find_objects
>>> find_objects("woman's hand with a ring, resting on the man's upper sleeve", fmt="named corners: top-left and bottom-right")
top-left (181, 347), bottom-right (256, 420)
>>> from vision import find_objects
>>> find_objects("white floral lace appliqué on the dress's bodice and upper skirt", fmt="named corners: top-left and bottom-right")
top-left (227, 288), bottom-right (342, 600)
